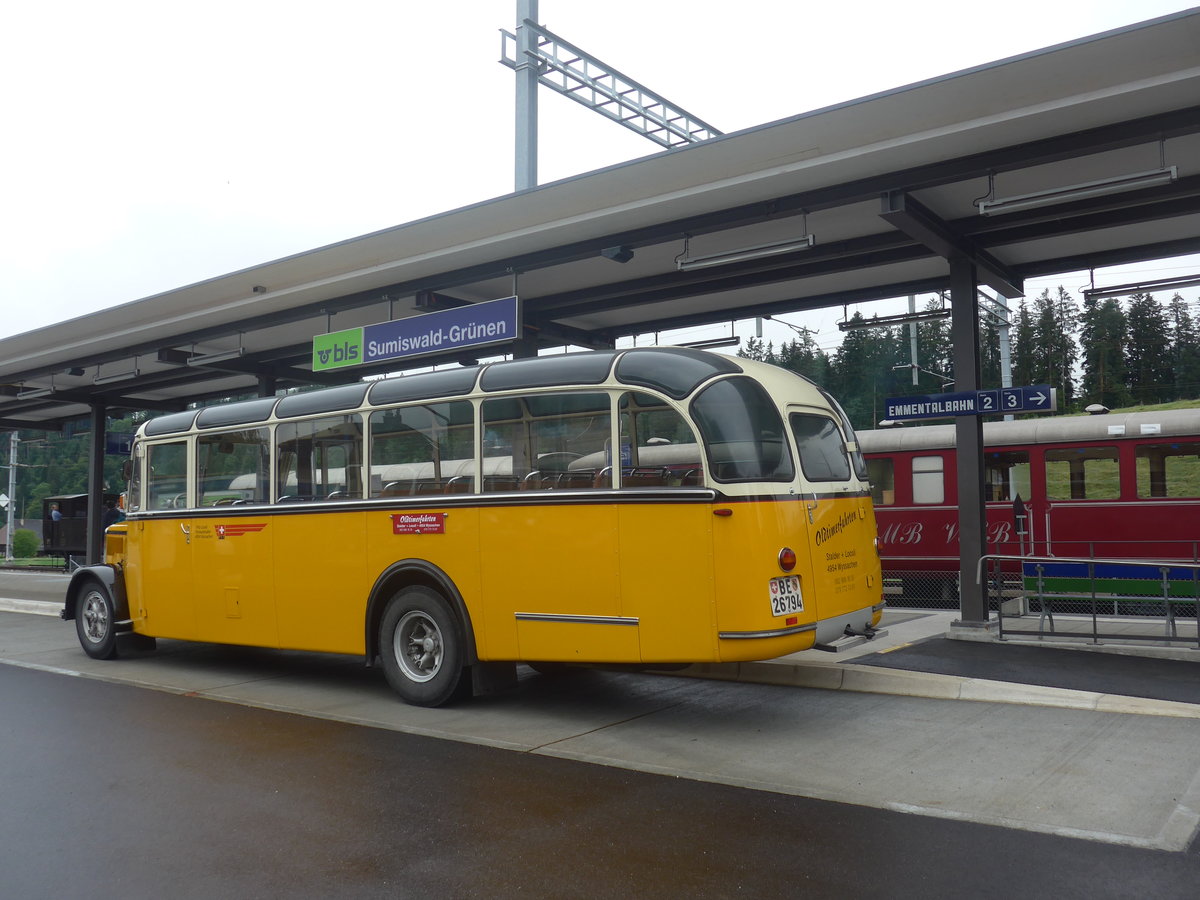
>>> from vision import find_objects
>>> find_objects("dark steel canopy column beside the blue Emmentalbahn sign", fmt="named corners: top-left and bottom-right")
top-left (949, 254), bottom-right (988, 625)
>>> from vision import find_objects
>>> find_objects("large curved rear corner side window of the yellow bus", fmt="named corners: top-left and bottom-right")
top-left (691, 377), bottom-right (796, 481)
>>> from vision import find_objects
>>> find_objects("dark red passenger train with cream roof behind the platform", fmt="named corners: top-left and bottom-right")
top-left (858, 409), bottom-right (1200, 602)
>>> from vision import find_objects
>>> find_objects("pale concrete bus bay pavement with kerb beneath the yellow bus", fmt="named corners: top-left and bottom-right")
top-left (0, 575), bottom-right (1200, 853)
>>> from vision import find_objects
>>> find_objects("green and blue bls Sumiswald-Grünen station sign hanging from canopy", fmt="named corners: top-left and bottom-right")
top-left (312, 296), bottom-right (521, 372)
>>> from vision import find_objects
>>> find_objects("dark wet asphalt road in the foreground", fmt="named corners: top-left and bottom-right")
top-left (0, 665), bottom-right (1200, 899)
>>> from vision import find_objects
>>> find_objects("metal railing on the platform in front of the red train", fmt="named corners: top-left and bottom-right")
top-left (977, 553), bottom-right (1200, 648)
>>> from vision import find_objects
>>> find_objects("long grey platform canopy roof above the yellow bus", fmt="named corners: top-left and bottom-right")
top-left (0, 10), bottom-right (1200, 428)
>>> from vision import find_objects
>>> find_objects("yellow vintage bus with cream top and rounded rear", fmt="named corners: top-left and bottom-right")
top-left (62, 347), bottom-right (883, 706)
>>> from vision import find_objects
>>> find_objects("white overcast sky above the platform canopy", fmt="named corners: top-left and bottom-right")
top-left (0, 0), bottom-right (1200, 357)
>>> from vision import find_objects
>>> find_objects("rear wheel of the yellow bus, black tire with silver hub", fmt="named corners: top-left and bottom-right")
top-left (379, 584), bottom-right (470, 707)
